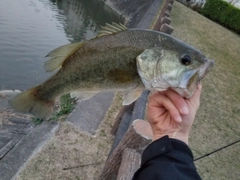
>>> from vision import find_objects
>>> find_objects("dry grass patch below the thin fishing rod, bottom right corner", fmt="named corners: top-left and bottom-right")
top-left (195, 142), bottom-right (240, 180)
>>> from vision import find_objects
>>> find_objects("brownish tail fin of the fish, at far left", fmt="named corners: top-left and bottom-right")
top-left (9, 87), bottom-right (54, 119)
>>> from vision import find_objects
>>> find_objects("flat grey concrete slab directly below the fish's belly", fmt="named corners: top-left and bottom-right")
top-left (67, 92), bottom-right (114, 135)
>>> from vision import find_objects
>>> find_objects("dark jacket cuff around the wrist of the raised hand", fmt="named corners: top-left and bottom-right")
top-left (141, 136), bottom-right (193, 164)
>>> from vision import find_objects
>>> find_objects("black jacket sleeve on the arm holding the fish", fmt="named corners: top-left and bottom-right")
top-left (133, 136), bottom-right (201, 180)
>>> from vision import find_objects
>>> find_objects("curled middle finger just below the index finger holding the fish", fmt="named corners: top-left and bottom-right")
top-left (148, 92), bottom-right (182, 123)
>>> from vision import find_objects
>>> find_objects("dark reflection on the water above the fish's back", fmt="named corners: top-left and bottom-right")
top-left (54, 0), bottom-right (123, 41)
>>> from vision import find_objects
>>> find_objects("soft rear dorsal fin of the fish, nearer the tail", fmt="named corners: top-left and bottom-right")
top-left (44, 42), bottom-right (84, 72)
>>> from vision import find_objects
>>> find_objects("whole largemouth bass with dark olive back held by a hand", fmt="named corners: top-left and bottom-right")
top-left (9, 23), bottom-right (214, 119)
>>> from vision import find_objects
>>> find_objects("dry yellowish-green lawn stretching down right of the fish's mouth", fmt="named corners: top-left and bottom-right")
top-left (171, 1), bottom-right (240, 180)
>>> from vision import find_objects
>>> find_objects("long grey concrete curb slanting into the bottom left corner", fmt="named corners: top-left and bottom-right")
top-left (0, 122), bottom-right (58, 180)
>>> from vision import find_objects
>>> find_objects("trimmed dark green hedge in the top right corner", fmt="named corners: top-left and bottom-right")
top-left (201, 0), bottom-right (240, 34)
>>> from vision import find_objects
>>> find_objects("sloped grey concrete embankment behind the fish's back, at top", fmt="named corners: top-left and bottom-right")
top-left (106, 0), bottom-right (174, 30)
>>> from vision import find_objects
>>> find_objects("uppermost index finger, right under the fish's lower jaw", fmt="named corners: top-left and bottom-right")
top-left (162, 89), bottom-right (189, 115)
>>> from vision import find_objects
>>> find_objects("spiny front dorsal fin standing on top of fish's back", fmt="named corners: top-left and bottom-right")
top-left (97, 22), bottom-right (128, 37)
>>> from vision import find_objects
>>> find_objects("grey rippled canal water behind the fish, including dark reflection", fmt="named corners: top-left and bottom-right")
top-left (0, 0), bottom-right (123, 90)
